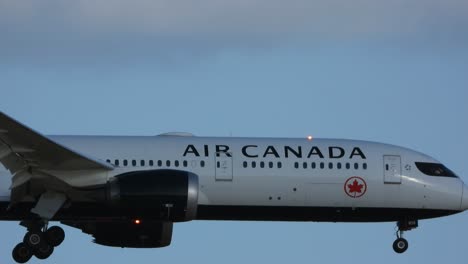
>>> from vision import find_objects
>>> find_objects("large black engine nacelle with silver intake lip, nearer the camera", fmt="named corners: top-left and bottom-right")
top-left (107, 170), bottom-right (198, 222)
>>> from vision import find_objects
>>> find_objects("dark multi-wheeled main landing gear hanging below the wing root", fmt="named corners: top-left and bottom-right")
top-left (12, 223), bottom-right (65, 263)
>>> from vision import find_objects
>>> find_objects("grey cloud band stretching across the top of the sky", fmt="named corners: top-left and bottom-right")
top-left (0, 0), bottom-right (468, 64)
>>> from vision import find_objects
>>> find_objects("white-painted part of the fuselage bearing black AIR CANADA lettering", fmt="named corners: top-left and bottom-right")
top-left (0, 136), bottom-right (467, 221)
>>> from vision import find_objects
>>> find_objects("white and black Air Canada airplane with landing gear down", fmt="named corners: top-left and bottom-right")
top-left (0, 112), bottom-right (468, 263)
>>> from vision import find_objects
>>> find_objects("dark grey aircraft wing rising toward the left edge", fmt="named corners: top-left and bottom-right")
top-left (0, 112), bottom-right (113, 174)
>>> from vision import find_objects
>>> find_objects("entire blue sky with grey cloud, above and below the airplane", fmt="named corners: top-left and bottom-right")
top-left (0, 0), bottom-right (468, 263)
